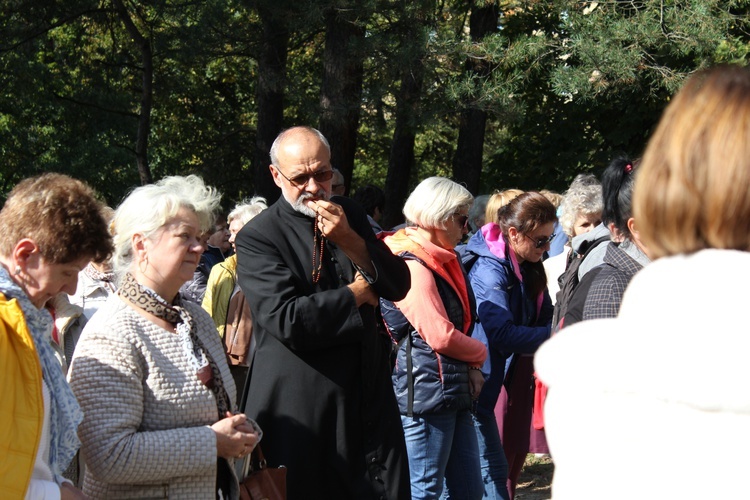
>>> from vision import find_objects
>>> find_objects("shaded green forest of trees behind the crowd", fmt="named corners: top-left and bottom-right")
top-left (0, 0), bottom-right (750, 226)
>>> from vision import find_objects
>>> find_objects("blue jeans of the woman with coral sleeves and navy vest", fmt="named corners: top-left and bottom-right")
top-left (401, 410), bottom-right (483, 500)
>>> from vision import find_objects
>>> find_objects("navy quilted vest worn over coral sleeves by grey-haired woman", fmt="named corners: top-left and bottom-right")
top-left (380, 252), bottom-right (475, 416)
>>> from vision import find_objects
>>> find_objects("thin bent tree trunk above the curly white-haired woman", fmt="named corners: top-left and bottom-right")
top-left (112, 0), bottom-right (154, 185)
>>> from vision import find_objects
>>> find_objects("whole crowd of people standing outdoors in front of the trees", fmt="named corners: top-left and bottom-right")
top-left (0, 66), bottom-right (750, 500)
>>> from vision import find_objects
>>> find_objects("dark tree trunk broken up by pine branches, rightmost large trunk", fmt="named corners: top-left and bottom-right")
top-left (453, 2), bottom-right (499, 194)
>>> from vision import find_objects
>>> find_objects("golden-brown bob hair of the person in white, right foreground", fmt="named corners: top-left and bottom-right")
top-left (633, 66), bottom-right (750, 258)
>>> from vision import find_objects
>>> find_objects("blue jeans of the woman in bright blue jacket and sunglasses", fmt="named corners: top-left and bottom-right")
top-left (472, 410), bottom-right (510, 500)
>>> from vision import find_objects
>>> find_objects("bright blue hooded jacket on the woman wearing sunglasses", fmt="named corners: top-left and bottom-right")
top-left (462, 224), bottom-right (552, 413)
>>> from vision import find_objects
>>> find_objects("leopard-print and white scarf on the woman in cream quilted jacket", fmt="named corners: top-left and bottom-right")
top-left (117, 273), bottom-right (232, 420)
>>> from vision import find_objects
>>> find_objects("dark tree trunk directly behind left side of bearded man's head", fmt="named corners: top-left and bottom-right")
top-left (254, 8), bottom-right (289, 203)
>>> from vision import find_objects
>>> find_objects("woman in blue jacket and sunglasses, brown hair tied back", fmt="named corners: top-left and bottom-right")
top-left (463, 192), bottom-right (556, 500)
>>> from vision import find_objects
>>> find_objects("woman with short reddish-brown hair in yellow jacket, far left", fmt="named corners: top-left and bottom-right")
top-left (0, 174), bottom-right (112, 499)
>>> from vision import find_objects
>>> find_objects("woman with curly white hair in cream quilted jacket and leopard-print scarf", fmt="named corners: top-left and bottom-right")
top-left (70, 176), bottom-right (260, 499)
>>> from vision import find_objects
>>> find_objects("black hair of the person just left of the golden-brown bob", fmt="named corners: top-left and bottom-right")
top-left (602, 156), bottom-right (640, 240)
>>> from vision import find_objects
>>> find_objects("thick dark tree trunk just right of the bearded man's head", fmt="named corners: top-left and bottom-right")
top-left (320, 2), bottom-right (365, 193)
